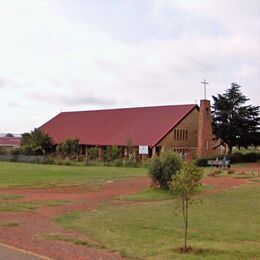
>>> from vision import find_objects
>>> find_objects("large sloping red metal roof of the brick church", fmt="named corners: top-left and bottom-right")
top-left (40, 105), bottom-right (198, 146)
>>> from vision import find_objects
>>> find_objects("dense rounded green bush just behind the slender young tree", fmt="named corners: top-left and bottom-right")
top-left (148, 152), bottom-right (182, 190)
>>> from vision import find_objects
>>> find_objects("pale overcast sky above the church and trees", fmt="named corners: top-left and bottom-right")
top-left (0, 0), bottom-right (260, 133)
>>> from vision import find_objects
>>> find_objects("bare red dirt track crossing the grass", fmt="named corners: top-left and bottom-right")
top-left (0, 164), bottom-right (260, 260)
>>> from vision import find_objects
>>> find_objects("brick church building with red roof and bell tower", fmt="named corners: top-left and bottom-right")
top-left (40, 100), bottom-right (213, 159)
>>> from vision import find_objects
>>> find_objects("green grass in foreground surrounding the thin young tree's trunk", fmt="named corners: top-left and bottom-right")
top-left (56, 187), bottom-right (260, 259)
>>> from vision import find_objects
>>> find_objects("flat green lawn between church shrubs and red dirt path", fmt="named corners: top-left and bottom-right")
top-left (0, 162), bottom-right (147, 188)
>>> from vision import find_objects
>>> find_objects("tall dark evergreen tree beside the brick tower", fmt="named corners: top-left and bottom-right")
top-left (212, 83), bottom-right (260, 153)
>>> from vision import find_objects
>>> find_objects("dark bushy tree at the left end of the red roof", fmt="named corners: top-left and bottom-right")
top-left (21, 128), bottom-right (52, 154)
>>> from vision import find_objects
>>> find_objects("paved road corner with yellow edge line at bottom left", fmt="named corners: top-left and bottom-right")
top-left (0, 243), bottom-right (50, 260)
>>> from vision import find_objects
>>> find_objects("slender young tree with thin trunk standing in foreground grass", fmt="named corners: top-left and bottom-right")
top-left (171, 163), bottom-right (202, 252)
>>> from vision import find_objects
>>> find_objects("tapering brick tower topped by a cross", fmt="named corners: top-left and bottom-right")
top-left (197, 99), bottom-right (213, 158)
